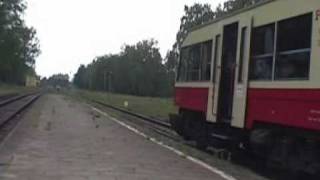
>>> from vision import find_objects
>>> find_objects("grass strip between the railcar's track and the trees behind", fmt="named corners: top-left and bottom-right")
top-left (69, 90), bottom-right (177, 120)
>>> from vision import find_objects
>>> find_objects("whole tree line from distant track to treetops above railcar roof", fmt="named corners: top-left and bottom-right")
top-left (73, 0), bottom-right (263, 97)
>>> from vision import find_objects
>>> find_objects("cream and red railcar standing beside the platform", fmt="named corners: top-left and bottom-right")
top-left (170, 0), bottom-right (320, 173)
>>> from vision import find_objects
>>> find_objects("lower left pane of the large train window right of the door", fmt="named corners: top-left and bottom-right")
top-left (250, 56), bottom-right (273, 80)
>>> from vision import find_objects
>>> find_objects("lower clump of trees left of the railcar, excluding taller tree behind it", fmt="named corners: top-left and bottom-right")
top-left (73, 39), bottom-right (172, 96)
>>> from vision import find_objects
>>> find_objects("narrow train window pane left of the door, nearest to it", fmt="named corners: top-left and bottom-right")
top-left (201, 41), bottom-right (212, 81)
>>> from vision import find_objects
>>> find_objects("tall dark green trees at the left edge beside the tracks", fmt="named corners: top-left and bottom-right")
top-left (0, 0), bottom-right (40, 84)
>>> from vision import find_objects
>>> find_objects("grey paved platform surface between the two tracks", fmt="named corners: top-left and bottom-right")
top-left (0, 95), bottom-right (222, 180)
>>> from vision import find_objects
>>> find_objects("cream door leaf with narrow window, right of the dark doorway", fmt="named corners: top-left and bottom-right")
top-left (231, 18), bottom-right (252, 128)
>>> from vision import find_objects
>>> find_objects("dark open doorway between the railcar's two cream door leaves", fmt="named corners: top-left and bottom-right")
top-left (217, 23), bottom-right (239, 124)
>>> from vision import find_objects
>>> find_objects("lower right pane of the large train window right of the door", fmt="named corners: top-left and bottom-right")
top-left (275, 52), bottom-right (310, 80)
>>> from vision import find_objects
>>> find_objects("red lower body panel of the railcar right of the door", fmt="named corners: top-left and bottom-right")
top-left (246, 89), bottom-right (320, 130)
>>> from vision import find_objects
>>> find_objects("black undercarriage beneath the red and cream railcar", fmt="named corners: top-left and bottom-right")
top-left (170, 110), bottom-right (320, 176)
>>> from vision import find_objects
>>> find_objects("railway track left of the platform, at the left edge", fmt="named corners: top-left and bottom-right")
top-left (0, 92), bottom-right (41, 142)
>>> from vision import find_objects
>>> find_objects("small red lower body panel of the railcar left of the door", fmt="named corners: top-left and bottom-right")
top-left (175, 87), bottom-right (209, 113)
